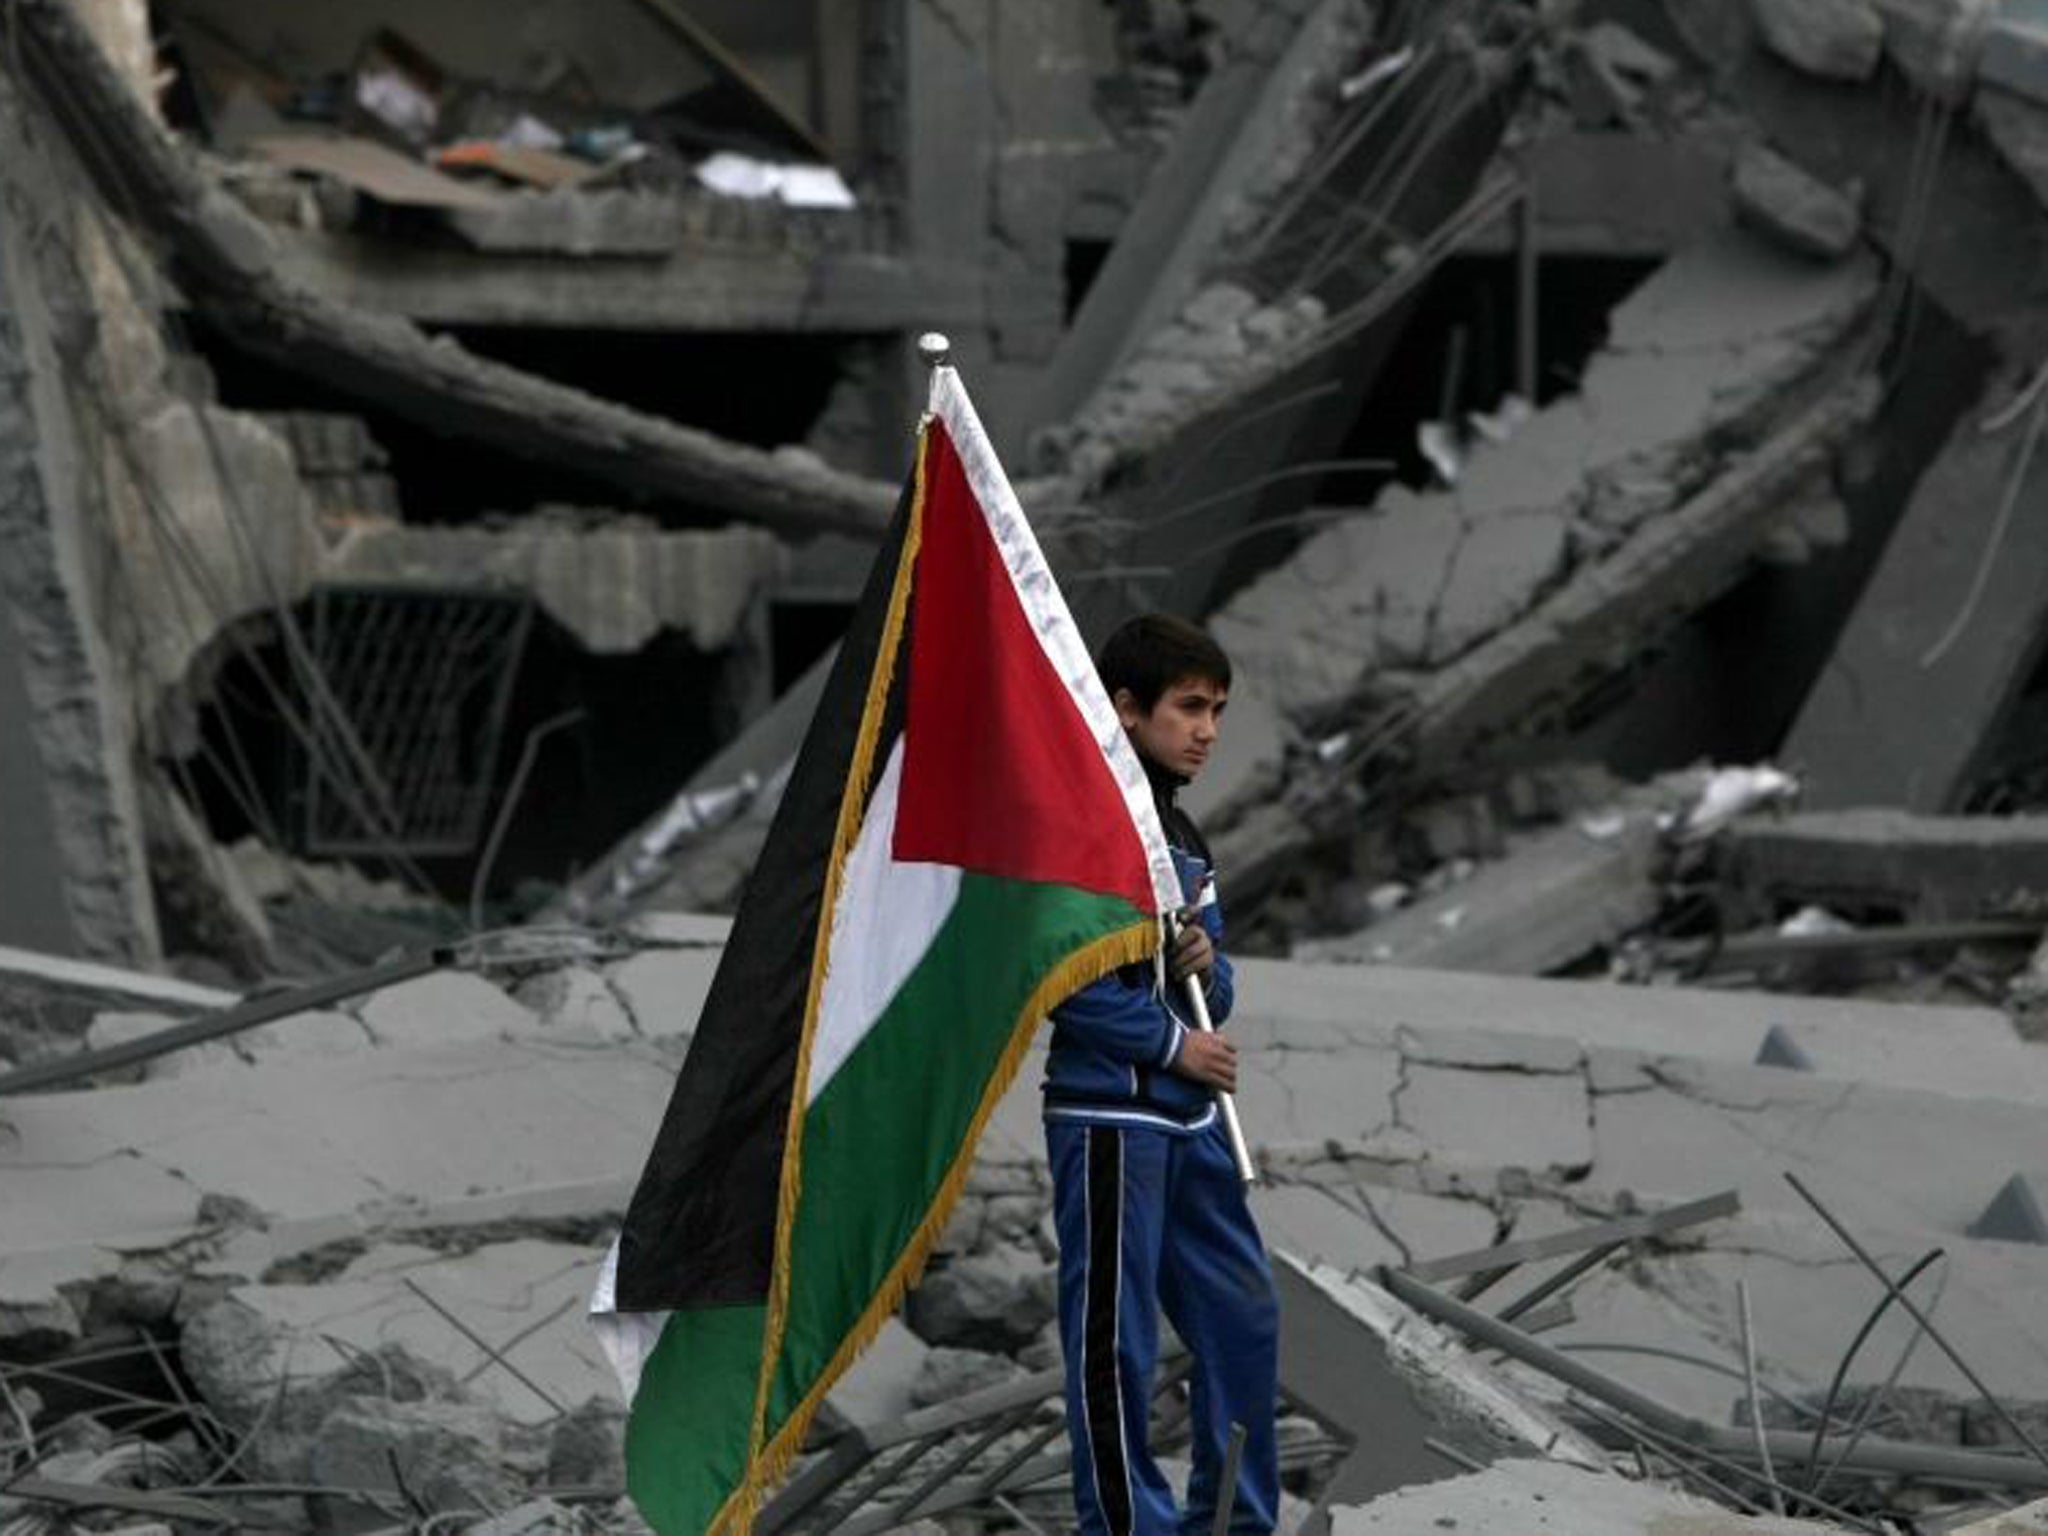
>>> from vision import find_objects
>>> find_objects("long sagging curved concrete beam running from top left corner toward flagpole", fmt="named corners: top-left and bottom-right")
top-left (8, 0), bottom-right (895, 537)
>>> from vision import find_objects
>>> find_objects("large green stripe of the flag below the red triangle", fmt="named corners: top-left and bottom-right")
top-left (768, 874), bottom-right (1145, 1438)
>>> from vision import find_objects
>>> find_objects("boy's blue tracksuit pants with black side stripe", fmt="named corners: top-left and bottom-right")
top-left (1044, 1120), bottom-right (1280, 1536)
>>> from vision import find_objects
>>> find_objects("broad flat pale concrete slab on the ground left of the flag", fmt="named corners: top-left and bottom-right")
top-left (0, 1026), bottom-right (676, 1296)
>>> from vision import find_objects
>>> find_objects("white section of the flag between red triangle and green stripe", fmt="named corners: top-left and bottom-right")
top-left (805, 735), bottom-right (961, 1104)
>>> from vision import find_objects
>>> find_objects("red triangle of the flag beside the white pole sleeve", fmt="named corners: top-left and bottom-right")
top-left (893, 420), bottom-right (1153, 911)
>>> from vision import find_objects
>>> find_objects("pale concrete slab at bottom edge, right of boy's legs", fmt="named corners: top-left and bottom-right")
top-left (1329, 1458), bottom-right (1841, 1536)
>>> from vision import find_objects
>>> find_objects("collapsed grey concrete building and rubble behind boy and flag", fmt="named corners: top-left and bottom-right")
top-left (0, 0), bottom-right (2048, 1536)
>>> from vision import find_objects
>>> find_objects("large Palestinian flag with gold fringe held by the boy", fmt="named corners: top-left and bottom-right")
top-left (592, 369), bottom-right (1180, 1536)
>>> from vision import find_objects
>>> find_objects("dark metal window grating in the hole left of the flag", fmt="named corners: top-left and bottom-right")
top-left (299, 588), bottom-right (532, 856)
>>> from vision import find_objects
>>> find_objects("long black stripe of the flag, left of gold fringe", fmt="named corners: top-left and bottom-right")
top-left (618, 477), bottom-right (915, 1311)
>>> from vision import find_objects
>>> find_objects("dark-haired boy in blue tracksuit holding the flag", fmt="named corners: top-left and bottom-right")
top-left (1044, 614), bottom-right (1280, 1536)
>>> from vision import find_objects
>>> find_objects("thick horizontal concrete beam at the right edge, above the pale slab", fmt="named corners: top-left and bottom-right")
top-left (1720, 807), bottom-right (2048, 924)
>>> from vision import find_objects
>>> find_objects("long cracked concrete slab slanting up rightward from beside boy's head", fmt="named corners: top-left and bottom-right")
top-left (1210, 233), bottom-right (1876, 733)
